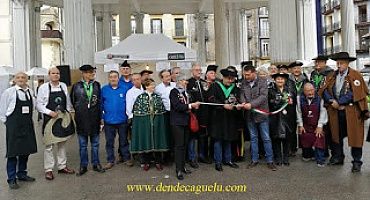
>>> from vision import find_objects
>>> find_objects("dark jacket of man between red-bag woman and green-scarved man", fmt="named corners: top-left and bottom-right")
top-left (186, 78), bottom-right (209, 126)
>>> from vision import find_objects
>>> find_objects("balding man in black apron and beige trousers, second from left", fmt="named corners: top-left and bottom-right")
top-left (37, 68), bottom-right (75, 180)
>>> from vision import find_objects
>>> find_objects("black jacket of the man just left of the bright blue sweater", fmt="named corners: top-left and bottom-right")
top-left (71, 81), bottom-right (101, 136)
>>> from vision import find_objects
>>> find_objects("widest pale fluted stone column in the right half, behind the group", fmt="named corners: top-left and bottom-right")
top-left (269, 0), bottom-right (298, 63)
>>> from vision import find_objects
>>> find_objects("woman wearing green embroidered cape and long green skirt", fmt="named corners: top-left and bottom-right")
top-left (130, 79), bottom-right (169, 171)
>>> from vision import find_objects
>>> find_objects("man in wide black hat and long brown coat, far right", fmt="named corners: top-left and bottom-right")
top-left (319, 52), bottom-right (368, 172)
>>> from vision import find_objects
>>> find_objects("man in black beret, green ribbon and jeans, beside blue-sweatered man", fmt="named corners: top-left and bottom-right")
top-left (71, 65), bottom-right (105, 176)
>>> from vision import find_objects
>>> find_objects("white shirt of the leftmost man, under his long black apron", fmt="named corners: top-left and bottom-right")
top-left (0, 85), bottom-right (35, 122)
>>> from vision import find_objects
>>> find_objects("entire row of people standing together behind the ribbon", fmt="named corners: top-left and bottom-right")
top-left (0, 52), bottom-right (369, 189)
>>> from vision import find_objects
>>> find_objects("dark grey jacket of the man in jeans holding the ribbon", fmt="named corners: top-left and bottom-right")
top-left (240, 77), bottom-right (269, 123)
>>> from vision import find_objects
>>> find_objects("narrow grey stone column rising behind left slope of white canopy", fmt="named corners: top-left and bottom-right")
top-left (118, 0), bottom-right (131, 41)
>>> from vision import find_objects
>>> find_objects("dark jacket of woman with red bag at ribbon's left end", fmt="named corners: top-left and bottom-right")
top-left (170, 88), bottom-right (189, 126)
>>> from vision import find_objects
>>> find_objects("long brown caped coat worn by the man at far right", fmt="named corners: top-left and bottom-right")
top-left (319, 68), bottom-right (368, 147)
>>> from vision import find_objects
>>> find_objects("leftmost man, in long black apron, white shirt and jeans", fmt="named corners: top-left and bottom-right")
top-left (0, 72), bottom-right (37, 189)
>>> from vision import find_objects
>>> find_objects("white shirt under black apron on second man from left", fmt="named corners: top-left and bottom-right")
top-left (36, 82), bottom-right (72, 115)
